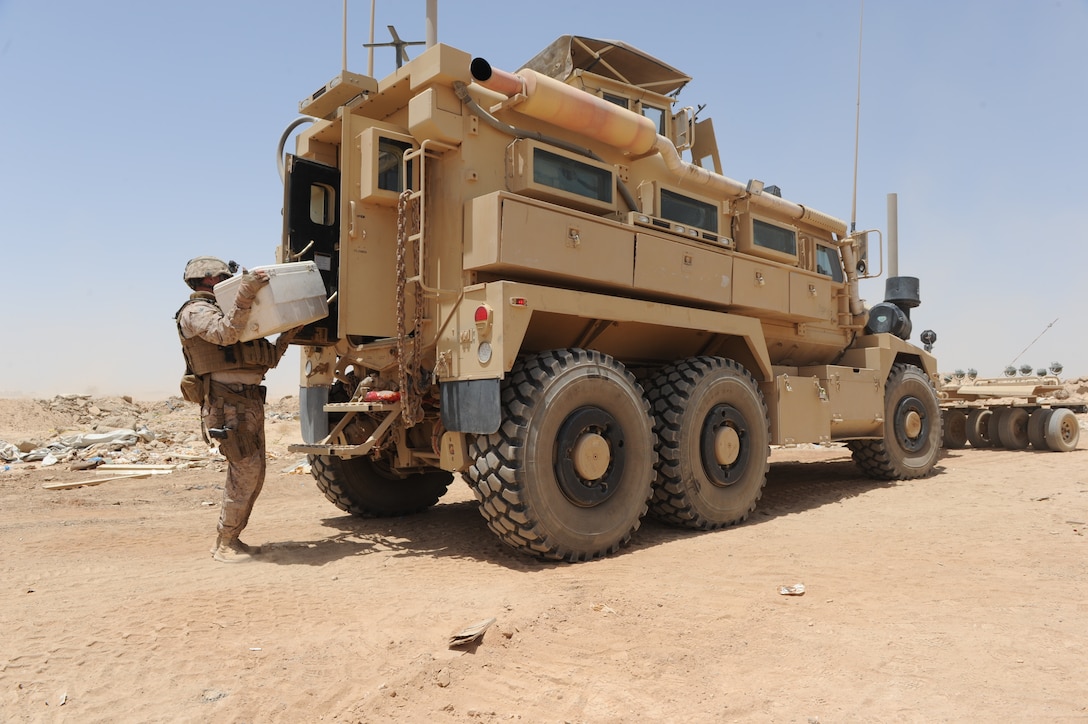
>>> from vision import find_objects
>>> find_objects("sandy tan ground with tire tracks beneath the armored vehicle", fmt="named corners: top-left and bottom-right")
top-left (0, 398), bottom-right (1088, 723)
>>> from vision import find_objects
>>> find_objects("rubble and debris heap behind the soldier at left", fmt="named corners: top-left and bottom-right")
top-left (0, 394), bottom-right (298, 471)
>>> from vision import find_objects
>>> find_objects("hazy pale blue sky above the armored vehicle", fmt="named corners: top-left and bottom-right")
top-left (0, 0), bottom-right (1088, 400)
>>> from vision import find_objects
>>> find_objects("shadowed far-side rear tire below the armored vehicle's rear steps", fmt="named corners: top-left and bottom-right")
top-left (310, 455), bottom-right (454, 518)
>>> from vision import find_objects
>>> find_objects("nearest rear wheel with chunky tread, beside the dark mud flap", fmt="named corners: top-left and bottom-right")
top-left (468, 349), bottom-right (656, 562)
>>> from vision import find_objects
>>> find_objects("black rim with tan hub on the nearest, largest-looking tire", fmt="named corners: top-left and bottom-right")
top-left (553, 407), bottom-right (625, 507)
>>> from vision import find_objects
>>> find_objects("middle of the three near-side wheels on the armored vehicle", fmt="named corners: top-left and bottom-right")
top-left (647, 357), bottom-right (770, 530)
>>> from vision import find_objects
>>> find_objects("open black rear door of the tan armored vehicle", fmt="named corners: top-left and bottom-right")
top-left (283, 155), bottom-right (339, 345)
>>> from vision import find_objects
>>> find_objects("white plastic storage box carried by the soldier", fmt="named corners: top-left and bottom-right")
top-left (214, 261), bottom-right (329, 342)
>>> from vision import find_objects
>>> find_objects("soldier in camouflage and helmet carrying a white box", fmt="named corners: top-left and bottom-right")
top-left (175, 257), bottom-right (293, 563)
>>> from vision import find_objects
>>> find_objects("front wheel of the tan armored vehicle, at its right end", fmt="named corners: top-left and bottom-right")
top-left (849, 363), bottom-right (941, 480)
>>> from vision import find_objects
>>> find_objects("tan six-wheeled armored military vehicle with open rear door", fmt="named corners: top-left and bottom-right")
top-left (280, 36), bottom-right (941, 561)
